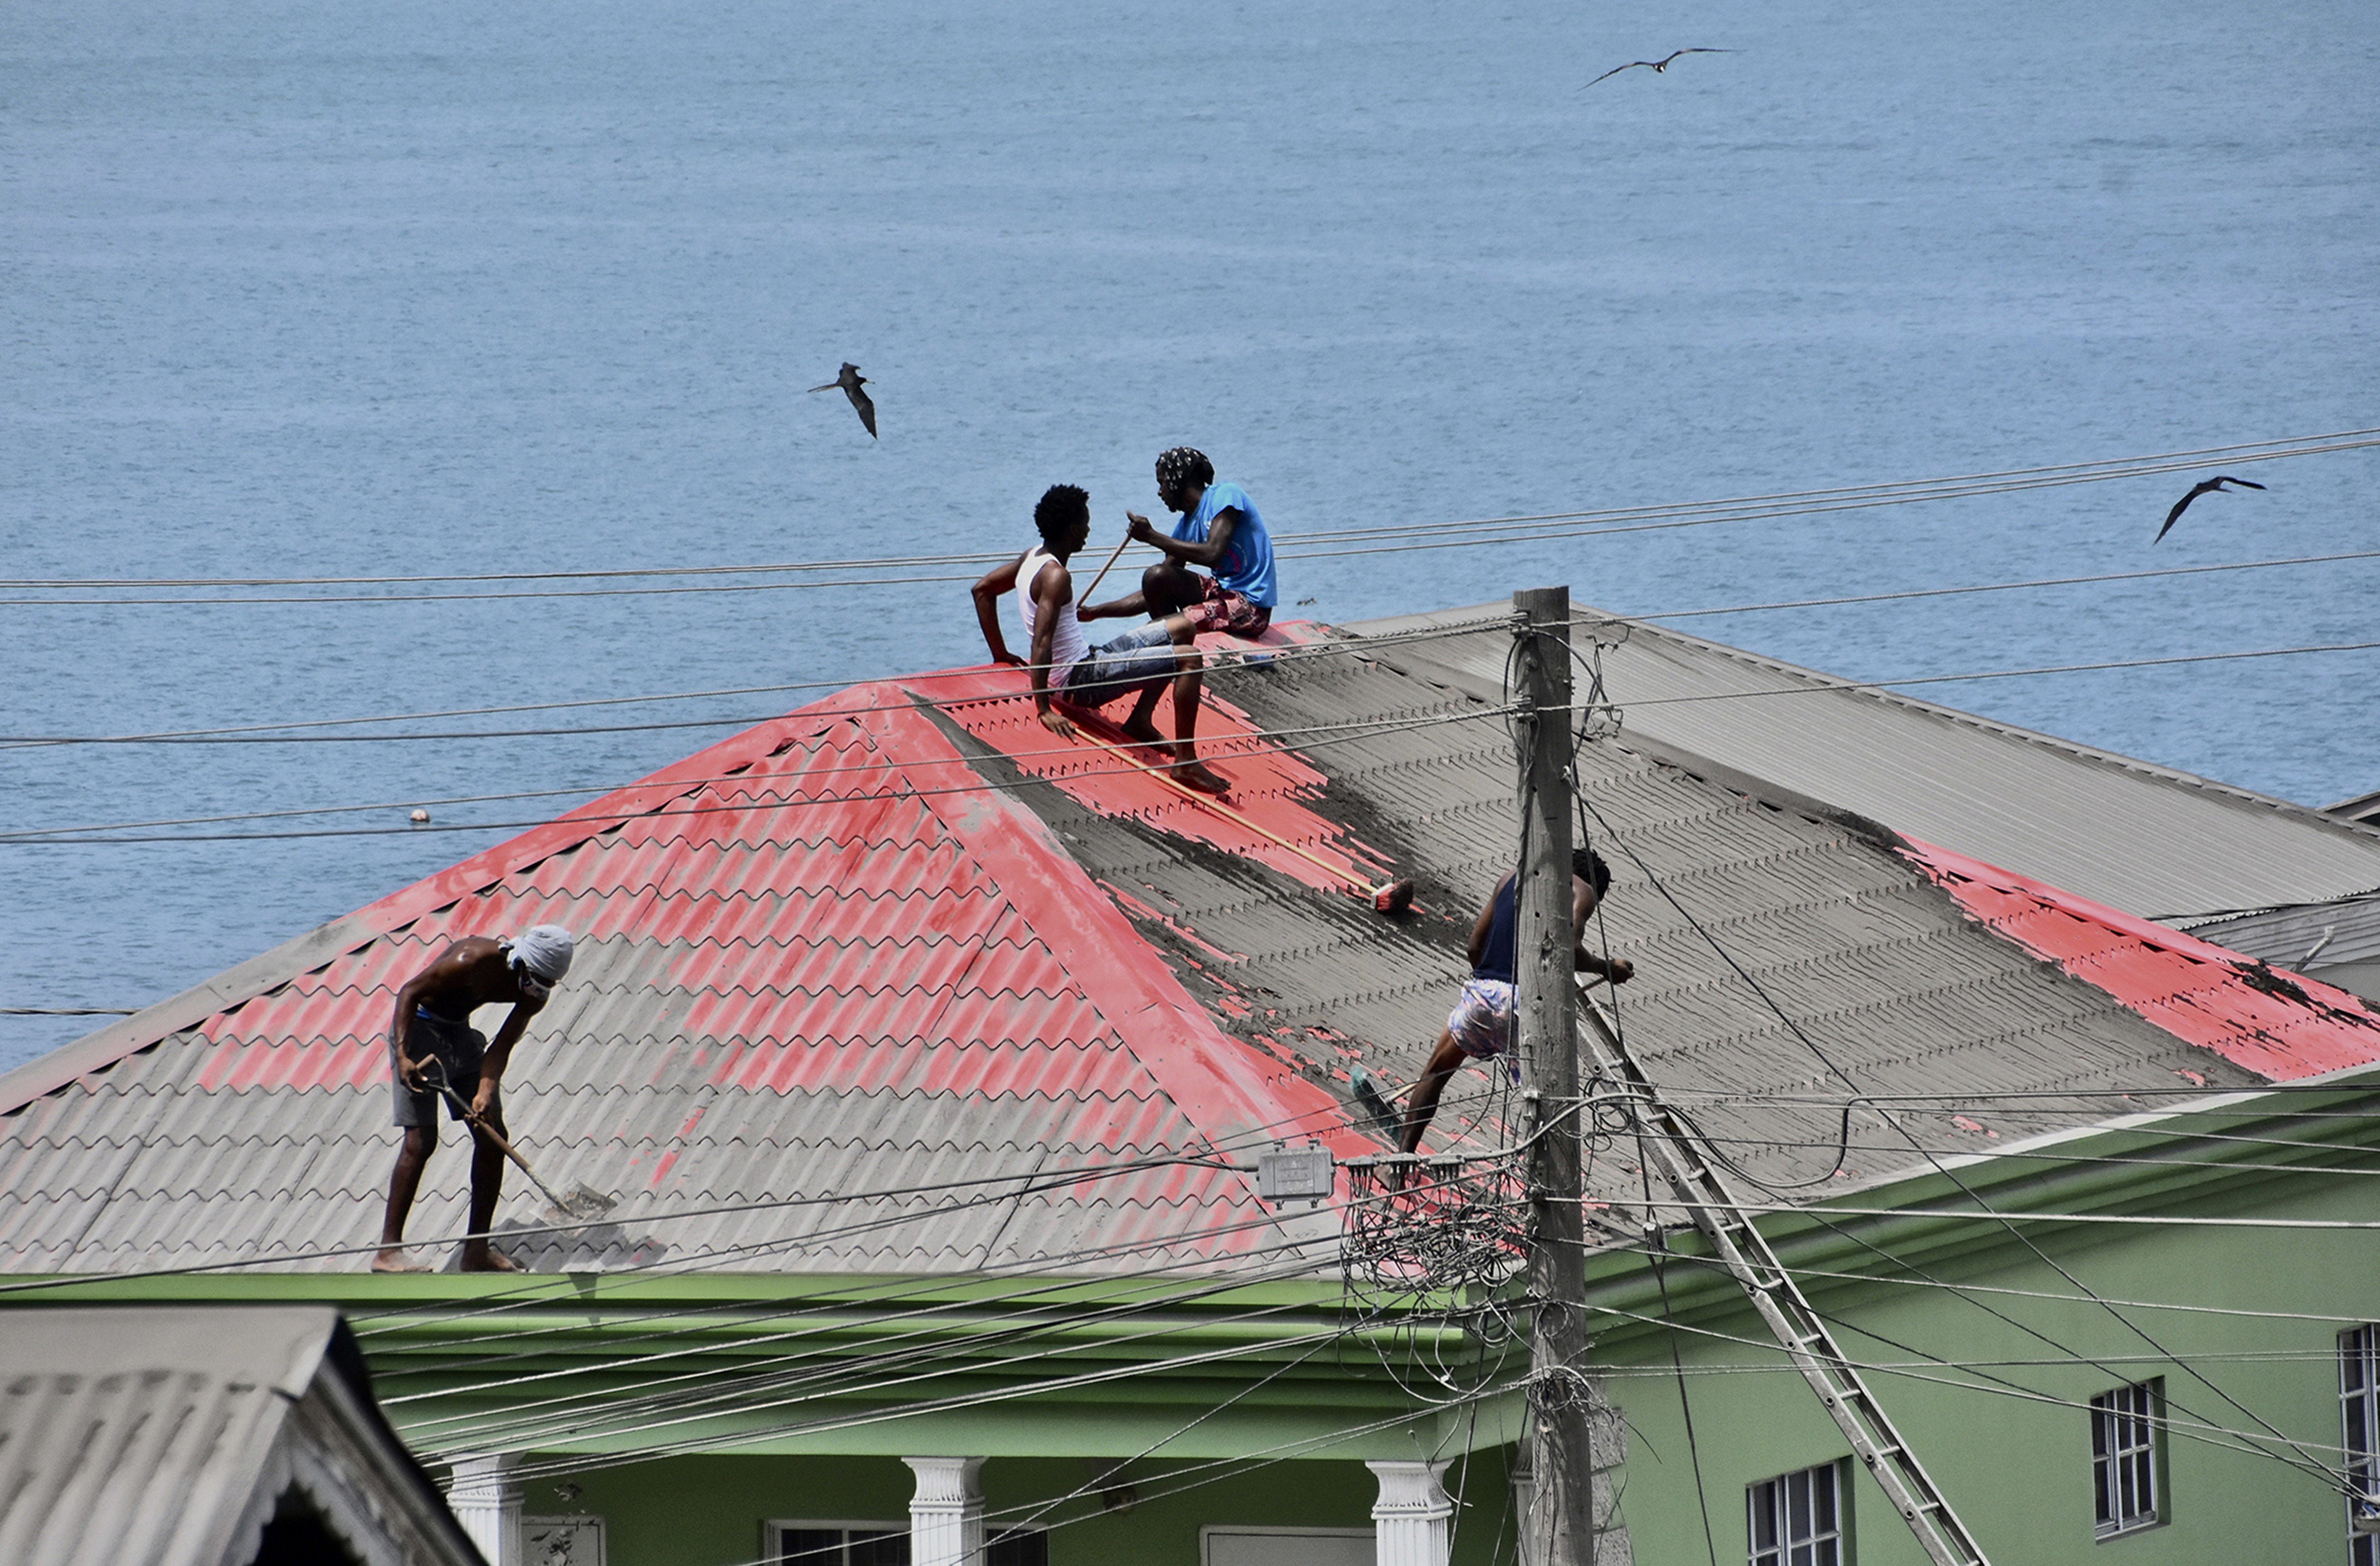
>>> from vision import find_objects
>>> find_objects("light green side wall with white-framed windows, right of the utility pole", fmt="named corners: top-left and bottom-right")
top-left (1609, 1176), bottom-right (2380, 1566)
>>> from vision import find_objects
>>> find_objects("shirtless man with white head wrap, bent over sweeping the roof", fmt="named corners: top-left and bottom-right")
top-left (371, 923), bottom-right (571, 1273)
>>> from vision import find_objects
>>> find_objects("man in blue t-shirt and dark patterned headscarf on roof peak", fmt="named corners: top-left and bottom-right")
top-left (1107, 445), bottom-right (1280, 640)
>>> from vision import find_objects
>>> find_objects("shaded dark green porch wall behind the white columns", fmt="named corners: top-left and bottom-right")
top-left (526, 1450), bottom-right (1511, 1566)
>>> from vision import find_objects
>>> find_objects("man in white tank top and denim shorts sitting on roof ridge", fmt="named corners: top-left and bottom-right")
top-left (973, 483), bottom-right (1231, 795)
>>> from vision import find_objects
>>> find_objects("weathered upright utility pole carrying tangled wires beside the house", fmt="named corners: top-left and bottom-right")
top-left (1511, 588), bottom-right (1595, 1566)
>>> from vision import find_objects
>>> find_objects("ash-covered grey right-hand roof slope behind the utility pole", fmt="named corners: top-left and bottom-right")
top-left (1035, 631), bottom-right (2380, 1199)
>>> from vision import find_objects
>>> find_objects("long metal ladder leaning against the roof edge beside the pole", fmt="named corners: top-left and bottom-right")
top-left (1578, 985), bottom-right (1990, 1566)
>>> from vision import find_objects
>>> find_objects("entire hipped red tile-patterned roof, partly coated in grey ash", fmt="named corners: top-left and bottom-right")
top-left (0, 614), bottom-right (2361, 1273)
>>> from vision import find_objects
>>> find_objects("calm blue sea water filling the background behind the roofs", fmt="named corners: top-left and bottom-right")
top-left (0, 0), bottom-right (2380, 1066)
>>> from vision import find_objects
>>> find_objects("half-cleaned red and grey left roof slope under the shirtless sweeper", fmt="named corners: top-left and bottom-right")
top-left (0, 671), bottom-right (1361, 1271)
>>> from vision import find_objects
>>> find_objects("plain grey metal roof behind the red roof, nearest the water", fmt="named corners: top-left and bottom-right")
top-left (1347, 605), bottom-right (2380, 923)
